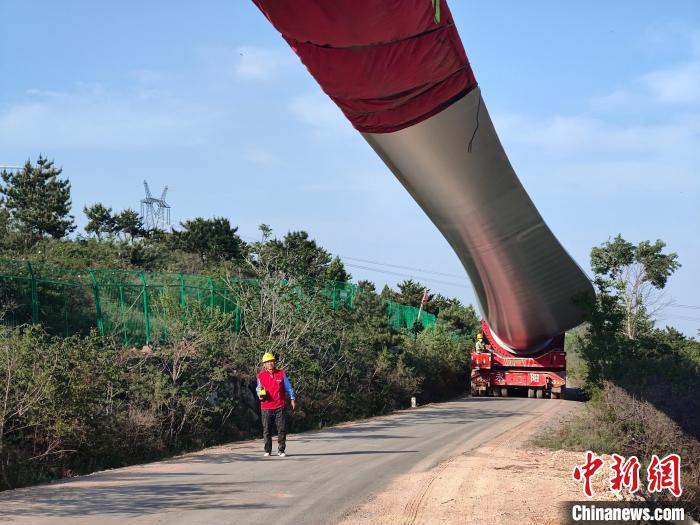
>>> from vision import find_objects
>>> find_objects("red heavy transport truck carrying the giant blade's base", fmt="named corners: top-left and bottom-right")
top-left (471, 321), bottom-right (566, 399)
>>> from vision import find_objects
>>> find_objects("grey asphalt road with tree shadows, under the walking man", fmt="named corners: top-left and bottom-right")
top-left (0, 398), bottom-right (564, 525)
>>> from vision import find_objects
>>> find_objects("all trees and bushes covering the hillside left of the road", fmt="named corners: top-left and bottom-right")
top-left (0, 158), bottom-right (478, 488)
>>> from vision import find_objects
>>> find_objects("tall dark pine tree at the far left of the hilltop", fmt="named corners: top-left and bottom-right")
top-left (0, 155), bottom-right (75, 243)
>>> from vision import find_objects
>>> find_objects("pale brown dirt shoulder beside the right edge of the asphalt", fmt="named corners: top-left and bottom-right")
top-left (343, 400), bottom-right (620, 525)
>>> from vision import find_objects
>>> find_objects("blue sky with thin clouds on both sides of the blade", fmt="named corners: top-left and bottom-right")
top-left (0, 0), bottom-right (700, 334)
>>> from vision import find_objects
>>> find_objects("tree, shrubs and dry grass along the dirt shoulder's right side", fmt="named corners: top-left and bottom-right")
top-left (539, 236), bottom-right (700, 517)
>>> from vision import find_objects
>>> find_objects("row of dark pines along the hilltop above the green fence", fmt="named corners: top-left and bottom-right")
top-left (0, 156), bottom-right (471, 322)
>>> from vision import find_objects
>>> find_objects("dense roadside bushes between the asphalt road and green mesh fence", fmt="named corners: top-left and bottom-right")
top-left (0, 276), bottom-right (476, 488)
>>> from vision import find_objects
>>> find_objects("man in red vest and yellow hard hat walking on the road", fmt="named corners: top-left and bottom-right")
top-left (255, 352), bottom-right (297, 457)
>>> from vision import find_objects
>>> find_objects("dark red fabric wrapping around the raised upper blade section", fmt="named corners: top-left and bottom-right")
top-left (253, 0), bottom-right (477, 133)
